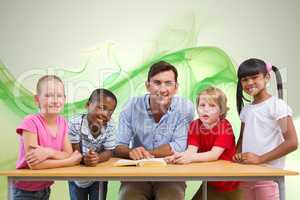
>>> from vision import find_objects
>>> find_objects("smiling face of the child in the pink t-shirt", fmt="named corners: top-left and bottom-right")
top-left (35, 79), bottom-right (66, 115)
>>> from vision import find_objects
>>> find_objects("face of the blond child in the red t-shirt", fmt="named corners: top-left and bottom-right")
top-left (197, 94), bottom-right (221, 127)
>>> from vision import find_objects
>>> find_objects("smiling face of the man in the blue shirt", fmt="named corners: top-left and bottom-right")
top-left (146, 70), bottom-right (178, 106)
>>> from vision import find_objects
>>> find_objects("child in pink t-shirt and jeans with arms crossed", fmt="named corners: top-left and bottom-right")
top-left (13, 75), bottom-right (82, 200)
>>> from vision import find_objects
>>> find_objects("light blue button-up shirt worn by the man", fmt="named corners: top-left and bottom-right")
top-left (116, 94), bottom-right (194, 152)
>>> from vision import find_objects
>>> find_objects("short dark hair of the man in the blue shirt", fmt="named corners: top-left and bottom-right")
top-left (147, 61), bottom-right (178, 83)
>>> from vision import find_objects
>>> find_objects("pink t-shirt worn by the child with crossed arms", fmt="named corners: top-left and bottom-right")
top-left (15, 114), bottom-right (68, 191)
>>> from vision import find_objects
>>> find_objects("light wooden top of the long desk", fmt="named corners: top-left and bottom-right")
top-left (0, 158), bottom-right (299, 178)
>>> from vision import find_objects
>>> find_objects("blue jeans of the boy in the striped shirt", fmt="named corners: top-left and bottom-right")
top-left (69, 181), bottom-right (107, 200)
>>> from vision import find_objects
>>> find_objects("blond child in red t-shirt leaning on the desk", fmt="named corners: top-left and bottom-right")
top-left (166, 87), bottom-right (241, 200)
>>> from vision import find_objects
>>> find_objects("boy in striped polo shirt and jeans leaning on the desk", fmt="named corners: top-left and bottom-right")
top-left (69, 89), bottom-right (117, 200)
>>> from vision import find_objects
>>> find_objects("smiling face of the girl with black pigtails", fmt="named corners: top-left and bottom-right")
top-left (240, 73), bottom-right (270, 97)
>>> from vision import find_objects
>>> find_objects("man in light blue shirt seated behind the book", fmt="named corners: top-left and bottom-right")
top-left (115, 61), bottom-right (194, 200)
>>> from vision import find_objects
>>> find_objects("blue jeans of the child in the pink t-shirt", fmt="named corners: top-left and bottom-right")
top-left (12, 187), bottom-right (50, 200)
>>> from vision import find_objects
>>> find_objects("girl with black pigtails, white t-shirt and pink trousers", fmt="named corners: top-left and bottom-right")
top-left (234, 58), bottom-right (298, 200)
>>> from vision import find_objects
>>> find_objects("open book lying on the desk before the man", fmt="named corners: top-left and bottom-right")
top-left (114, 158), bottom-right (167, 167)
